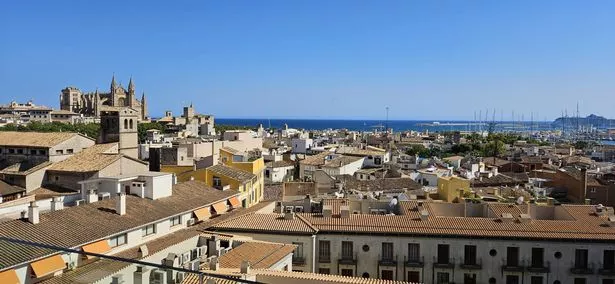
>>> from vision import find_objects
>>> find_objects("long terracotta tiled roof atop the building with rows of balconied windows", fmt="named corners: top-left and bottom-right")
top-left (215, 201), bottom-right (615, 241)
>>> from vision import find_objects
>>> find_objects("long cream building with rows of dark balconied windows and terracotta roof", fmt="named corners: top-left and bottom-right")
top-left (210, 199), bottom-right (615, 284)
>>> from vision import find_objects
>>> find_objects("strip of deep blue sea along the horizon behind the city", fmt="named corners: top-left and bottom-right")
top-left (216, 118), bottom-right (551, 132)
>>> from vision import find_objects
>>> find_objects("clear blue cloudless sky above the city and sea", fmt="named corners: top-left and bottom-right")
top-left (0, 0), bottom-right (615, 120)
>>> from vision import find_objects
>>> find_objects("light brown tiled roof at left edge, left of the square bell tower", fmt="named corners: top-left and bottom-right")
top-left (0, 131), bottom-right (79, 148)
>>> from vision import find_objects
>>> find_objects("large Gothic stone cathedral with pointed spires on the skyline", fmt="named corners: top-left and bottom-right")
top-left (60, 75), bottom-right (148, 121)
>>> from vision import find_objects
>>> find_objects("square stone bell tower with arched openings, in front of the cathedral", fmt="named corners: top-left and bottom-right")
top-left (98, 107), bottom-right (139, 159)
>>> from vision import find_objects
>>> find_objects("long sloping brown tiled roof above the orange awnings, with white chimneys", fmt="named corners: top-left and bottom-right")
top-left (0, 181), bottom-right (237, 269)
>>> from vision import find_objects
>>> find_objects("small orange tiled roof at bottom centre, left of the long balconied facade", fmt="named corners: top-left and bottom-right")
top-left (220, 242), bottom-right (296, 269)
